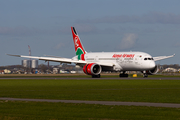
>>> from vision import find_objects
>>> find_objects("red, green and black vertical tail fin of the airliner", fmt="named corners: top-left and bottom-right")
top-left (71, 27), bottom-right (86, 56)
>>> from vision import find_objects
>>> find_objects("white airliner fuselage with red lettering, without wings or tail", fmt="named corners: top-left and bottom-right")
top-left (81, 52), bottom-right (155, 71)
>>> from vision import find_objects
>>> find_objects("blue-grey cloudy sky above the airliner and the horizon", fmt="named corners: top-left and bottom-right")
top-left (0, 0), bottom-right (180, 66)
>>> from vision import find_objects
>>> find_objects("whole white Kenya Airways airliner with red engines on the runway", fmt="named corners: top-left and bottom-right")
top-left (7, 27), bottom-right (175, 78)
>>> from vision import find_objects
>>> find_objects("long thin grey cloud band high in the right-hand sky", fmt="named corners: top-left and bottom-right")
top-left (79, 12), bottom-right (180, 24)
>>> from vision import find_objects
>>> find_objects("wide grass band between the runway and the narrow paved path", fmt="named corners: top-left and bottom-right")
top-left (0, 79), bottom-right (180, 103)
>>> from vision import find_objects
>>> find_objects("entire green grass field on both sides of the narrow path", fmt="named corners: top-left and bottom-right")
top-left (0, 75), bottom-right (180, 120)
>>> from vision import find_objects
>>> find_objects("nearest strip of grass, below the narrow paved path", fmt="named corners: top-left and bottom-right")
top-left (0, 101), bottom-right (180, 120)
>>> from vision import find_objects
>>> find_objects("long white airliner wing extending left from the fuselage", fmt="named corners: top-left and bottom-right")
top-left (7, 54), bottom-right (87, 64)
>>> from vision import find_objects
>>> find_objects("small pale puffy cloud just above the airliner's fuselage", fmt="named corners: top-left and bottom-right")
top-left (117, 33), bottom-right (138, 50)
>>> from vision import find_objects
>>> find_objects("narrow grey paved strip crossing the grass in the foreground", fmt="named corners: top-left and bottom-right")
top-left (0, 98), bottom-right (180, 108)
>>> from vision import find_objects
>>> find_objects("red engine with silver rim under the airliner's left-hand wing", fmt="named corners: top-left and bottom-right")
top-left (83, 63), bottom-right (101, 75)
